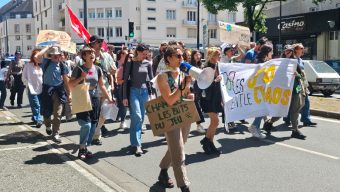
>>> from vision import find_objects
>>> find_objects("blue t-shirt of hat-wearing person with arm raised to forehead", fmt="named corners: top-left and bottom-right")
top-left (41, 58), bottom-right (69, 86)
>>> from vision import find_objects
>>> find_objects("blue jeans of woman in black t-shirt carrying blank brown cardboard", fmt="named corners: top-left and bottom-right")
top-left (78, 119), bottom-right (97, 147)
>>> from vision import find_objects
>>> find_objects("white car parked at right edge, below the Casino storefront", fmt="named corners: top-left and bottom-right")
top-left (303, 60), bottom-right (340, 97)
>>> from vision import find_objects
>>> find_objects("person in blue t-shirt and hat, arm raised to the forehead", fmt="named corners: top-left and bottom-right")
top-left (34, 46), bottom-right (71, 143)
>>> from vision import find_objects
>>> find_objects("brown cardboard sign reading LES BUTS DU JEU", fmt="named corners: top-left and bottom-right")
top-left (145, 97), bottom-right (199, 136)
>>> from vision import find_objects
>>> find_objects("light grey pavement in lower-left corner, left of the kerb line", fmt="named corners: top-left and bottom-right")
top-left (0, 111), bottom-right (125, 192)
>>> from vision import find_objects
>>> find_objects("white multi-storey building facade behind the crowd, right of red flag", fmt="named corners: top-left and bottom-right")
top-left (60, 0), bottom-right (243, 47)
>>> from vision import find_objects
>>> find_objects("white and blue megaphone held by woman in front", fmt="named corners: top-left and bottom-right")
top-left (179, 62), bottom-right (215, 89)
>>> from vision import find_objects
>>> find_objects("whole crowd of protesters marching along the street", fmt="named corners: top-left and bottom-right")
top-left (0, 35), bottom-right (316, 191)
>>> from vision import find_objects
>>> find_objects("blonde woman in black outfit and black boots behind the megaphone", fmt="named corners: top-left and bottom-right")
top-left (200, 47), bottom-right (223, 155)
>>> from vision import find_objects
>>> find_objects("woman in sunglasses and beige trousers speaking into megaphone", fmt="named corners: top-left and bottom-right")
top-left (155, 46), bottom-right (192, 192)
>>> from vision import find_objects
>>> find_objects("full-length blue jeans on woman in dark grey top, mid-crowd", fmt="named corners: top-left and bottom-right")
top-left (129, 87), bottom-right (149, 147)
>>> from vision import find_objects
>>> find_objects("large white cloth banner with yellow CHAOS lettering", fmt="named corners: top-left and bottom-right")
top-left (218, 59), bottom-right (297, 122)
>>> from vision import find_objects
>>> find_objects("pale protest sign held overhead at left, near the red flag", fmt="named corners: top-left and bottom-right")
top-left (36, 30), bottom-right (76, 54)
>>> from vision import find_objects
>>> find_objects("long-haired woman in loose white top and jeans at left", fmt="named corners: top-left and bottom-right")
top-left (22, 49), bottom-right (43, 128)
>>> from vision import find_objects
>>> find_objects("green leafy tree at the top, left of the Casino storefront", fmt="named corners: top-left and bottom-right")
top-left (201, 0), bottom-right (326, 33)
